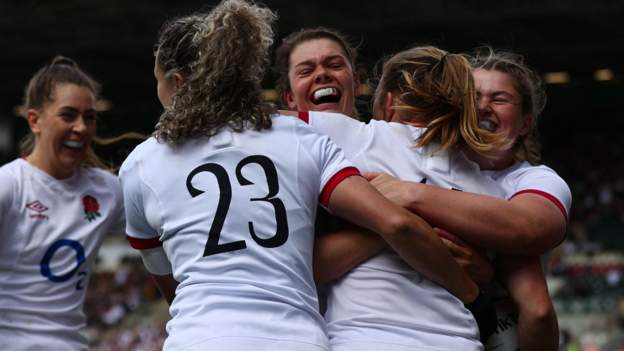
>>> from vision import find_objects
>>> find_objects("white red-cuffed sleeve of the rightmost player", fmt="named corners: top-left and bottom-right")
top-left (507, 166), bottom-right (572, 220)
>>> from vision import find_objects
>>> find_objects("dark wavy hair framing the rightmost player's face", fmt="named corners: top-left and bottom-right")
top-left (471, 46), bottom-right (546, 165)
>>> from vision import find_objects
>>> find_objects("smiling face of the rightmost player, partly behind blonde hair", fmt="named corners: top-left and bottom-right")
top-left (473, 69), bottom-right (532, 168)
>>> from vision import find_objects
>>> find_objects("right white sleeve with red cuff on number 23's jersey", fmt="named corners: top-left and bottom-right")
top-left (299, 121), bottom-right (360, 207)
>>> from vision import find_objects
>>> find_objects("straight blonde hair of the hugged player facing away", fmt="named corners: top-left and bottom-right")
top-left (374, 46), bottom-right (506, 155)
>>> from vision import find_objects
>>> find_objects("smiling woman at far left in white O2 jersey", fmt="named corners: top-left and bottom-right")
top-left (0, 56), bottom-right (124, 351)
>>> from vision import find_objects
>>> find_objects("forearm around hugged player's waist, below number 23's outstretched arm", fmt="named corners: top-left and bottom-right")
top-left (314, 227), bottom-right (386, 283)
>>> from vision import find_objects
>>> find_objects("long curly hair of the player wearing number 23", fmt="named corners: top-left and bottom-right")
top-left (154, 0), bottom-right (277, 144)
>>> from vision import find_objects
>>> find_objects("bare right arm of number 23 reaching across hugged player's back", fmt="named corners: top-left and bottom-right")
top-left (329, 177), bottom-right (479, 302)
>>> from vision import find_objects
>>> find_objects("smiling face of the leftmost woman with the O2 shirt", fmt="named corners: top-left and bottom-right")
top-left (27, 83), bottom-right (96, 179)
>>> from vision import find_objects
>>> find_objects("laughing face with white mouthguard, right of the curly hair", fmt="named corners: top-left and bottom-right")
top-left (284, 38), bottom-right (360, 116)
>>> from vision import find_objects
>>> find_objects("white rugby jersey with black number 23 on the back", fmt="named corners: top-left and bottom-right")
top-left (120, 116), bottom-right (359, 350)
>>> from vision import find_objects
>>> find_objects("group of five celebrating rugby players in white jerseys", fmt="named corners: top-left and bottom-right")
top-left (0, 0), bottom-right (571, 350)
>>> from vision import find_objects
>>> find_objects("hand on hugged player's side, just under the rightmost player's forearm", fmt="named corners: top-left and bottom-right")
top-left (434, 228), bottom-right (494, 286)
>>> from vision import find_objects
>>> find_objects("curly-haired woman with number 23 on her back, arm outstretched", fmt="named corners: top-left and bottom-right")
top-left (121, 0), bottom-right (478, 351)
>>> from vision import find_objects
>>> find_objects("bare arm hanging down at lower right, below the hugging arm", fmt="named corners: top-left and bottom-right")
top-left (496, 256), bottom-right (559, 351)
